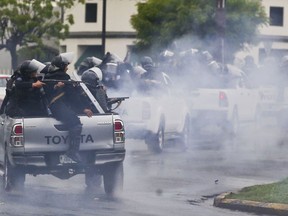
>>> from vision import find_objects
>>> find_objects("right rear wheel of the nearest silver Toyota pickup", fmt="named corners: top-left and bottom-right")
top-left (103, 162), bottom-right (124, 197)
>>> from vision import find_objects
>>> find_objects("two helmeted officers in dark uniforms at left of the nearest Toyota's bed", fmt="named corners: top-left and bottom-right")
top-left (1, 54), bottom-right (93, 163)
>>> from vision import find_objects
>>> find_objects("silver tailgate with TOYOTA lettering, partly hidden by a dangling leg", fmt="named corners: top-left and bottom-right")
top-left (23, 114), bottom-right (115, 152)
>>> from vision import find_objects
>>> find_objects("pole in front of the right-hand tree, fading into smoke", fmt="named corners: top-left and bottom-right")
top-left (215, 0), bottom-right (226, 65)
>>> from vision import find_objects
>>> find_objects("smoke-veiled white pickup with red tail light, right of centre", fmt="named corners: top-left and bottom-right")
top-left (187, 65), bottom-right (259, 136)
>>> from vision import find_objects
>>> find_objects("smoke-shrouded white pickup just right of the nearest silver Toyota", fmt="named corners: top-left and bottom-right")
top-left (117, 92), bottom-right (190, 153)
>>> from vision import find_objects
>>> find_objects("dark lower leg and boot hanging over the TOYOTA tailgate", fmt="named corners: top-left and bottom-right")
top-left (66, 125), bottom-right (82, 163)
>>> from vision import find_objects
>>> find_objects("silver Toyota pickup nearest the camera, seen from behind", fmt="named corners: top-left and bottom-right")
top-left (0, 79), bottom-right (125, 195)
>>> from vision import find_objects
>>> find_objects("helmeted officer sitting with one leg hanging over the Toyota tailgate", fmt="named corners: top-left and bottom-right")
top-left (45, 53), bottom-right (93, 163)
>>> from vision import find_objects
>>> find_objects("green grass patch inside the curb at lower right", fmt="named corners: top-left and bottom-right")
top-left (226, 178), bottom-right (288, 204)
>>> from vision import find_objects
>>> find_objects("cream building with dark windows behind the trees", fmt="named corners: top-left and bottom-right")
top-left (0, 0), bottom-right (288, 73)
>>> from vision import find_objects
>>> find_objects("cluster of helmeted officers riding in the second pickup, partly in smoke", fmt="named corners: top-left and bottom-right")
top-left (77, 52), bottom-right (169, 96)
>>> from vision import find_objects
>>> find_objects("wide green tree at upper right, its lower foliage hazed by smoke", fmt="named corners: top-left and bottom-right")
top-left (131, 0), bottom-right (268, 62)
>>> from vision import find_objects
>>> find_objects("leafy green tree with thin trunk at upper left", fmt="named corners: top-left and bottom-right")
top-left (0, 0), bottom-right (85, 69)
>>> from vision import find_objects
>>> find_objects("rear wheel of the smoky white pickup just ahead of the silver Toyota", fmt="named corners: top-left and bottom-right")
top-left (145, 123), bottom-right (164, 154)
